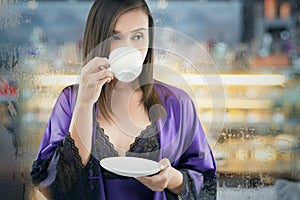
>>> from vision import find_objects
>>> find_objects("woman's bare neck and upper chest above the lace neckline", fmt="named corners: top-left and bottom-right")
top-left (98, 89), bottom-right (151, 156)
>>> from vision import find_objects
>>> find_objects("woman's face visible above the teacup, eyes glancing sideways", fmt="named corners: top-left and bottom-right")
top-left (110, 9), bottom-right (149, 60)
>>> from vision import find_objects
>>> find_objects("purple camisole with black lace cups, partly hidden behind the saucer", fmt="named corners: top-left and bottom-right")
top-left (92, 123), bottom-right (160, 199)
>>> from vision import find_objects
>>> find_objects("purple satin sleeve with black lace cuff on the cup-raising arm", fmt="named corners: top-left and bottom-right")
top-left (31, 85), bottom-right (94, 199)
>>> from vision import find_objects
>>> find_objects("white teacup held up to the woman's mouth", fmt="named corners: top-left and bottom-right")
top-left (109, 47), bottom-right (143, 82)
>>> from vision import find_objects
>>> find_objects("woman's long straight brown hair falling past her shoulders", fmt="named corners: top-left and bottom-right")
top-left (83, 0), bottom-right (161, 121)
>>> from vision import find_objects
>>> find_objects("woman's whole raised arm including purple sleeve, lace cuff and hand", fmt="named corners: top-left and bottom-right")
top-left (31, 58), bottom-right (112, 199)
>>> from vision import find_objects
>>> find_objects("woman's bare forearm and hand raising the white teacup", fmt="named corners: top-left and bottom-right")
top-left (69, 57), bottom-right (113, 165)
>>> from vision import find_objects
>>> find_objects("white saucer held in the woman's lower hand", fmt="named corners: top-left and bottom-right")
top-left (100, 157), bottom-right (160, 177)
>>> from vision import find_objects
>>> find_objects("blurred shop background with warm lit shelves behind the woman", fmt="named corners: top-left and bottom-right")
top-left (0, 0), bottom-right (300, 199)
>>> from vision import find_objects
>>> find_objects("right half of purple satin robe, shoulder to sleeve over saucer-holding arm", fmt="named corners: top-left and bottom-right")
top-left (156, 83), bottom-right (217, 200)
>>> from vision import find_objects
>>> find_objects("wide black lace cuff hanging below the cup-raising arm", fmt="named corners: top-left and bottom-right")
top-left (31, 134), bottom-right (88, 199)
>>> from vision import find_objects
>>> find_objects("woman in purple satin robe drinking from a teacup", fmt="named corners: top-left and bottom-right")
top-left (31, 0), bottom-right (216, 200)
